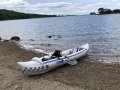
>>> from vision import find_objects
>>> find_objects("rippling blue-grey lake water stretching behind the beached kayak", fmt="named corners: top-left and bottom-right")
top-left (0, 14), bottom-right (120, 62)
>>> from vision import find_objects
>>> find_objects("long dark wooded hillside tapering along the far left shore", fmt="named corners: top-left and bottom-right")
top-left (0, 9), bottom-right (56, 20)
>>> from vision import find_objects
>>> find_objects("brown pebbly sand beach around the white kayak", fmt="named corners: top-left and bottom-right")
top-left (0, 41), bottom-right (120, 90)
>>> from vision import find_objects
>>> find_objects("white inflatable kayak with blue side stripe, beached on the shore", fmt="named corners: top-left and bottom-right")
top-left (17, 44), bottom-right (89, 75)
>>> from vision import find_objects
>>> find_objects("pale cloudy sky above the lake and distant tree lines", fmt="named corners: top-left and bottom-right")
top-left (0, 0), bottom-right (120, 15)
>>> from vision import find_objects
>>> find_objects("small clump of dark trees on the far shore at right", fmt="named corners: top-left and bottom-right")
top-left (98, 8), bottom-right (120, 14)
